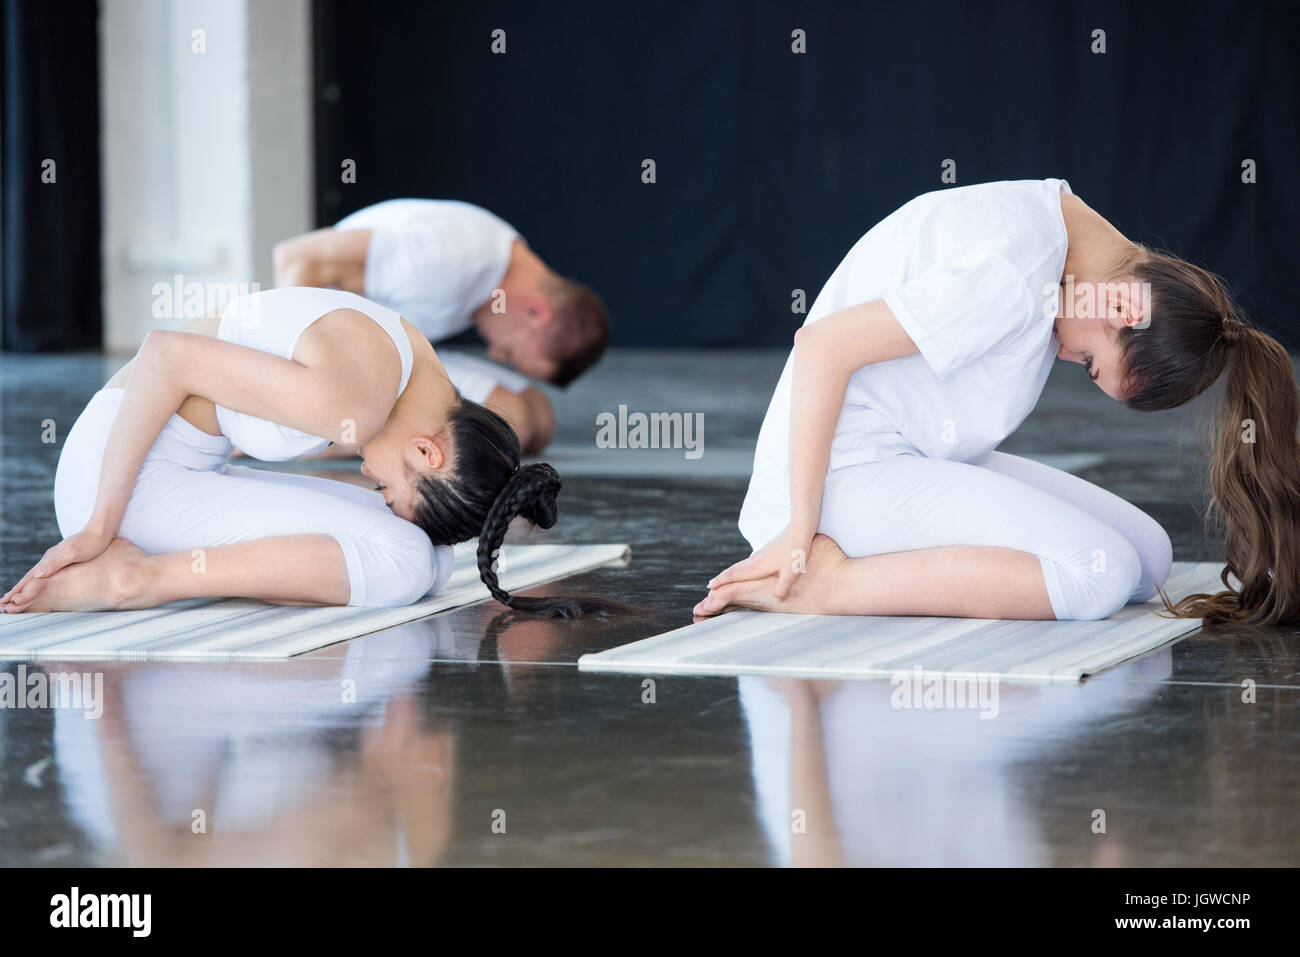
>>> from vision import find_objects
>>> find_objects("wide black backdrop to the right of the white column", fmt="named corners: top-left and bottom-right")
top-left (315, 0), bottom-right (1300, 347)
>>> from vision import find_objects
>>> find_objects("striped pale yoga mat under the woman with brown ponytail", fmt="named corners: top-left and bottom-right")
top-left (579, 562), bottom-right (1223, 681)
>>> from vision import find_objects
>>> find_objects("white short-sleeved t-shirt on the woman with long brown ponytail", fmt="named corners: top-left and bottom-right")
top-left (740, 179), bottom-right (1070, 548)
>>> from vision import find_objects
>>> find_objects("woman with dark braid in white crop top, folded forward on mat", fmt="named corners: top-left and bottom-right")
top-left (0, 289), bottom-right (588, 616)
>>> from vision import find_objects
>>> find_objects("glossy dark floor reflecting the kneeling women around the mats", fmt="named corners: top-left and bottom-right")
top-left (0, 352), bottom-right (1300, 866)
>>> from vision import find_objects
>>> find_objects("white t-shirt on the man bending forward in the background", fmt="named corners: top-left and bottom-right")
top-left (334, 199), bottom-right (523, 342)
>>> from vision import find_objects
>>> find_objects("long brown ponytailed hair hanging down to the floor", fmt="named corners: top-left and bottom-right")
top-left (1119, 246), bottom-right (1300, 624)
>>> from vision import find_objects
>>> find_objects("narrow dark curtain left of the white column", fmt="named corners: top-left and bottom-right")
top-left (0, 0), bottom-right (101, 352)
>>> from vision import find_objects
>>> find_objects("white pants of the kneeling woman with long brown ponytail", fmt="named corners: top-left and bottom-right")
top-left (741, 451), bottom-right (1174, 620)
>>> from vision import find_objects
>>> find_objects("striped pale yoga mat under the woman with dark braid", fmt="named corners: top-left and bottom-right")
top-left (0, 541), bottom-right (629, 659)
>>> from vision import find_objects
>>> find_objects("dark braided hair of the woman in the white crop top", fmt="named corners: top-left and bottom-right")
top-left (412, 397), bottom-right (610, 618)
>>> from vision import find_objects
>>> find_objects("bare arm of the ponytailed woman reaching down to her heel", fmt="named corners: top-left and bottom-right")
top-left (709, 299), bottom-right (918, 599)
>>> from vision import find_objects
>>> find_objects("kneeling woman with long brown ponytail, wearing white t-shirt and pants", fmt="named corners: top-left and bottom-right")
top-left (696, 179), bottom-right (1300, 624)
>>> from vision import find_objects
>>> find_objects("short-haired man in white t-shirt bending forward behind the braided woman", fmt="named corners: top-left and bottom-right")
top-left (274, 199), bottom-right (610, 454)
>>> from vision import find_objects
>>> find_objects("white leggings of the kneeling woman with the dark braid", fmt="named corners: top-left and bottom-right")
top-left (55, 389), bottom-right (452, 607)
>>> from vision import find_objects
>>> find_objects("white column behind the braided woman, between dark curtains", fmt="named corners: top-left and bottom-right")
top-left (100, 0), bottom-right (313, 352)
